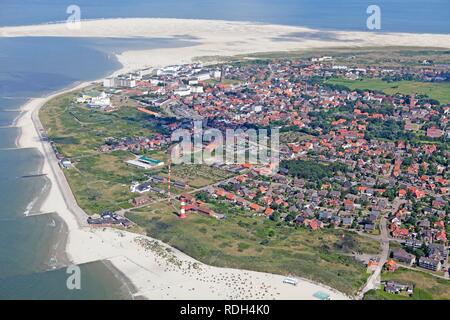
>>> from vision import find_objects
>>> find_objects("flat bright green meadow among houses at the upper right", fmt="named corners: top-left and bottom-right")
top-left (326, 79), bottom-right (450, 104)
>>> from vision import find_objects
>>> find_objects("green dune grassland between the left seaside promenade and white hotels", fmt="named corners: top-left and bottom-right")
top-left (39, 94), bottom-right (164, 214)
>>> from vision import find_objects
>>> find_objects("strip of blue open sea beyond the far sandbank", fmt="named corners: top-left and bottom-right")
top-left (0, 0), bottom-right (450, 33)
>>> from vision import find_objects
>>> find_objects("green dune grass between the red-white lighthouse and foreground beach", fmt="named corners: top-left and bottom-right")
top-left (127, 202), bottom-right (379, 294)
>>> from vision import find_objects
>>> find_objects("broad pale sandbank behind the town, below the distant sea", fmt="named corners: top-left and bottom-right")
top-left (0, 18), bottom-right (450, 72)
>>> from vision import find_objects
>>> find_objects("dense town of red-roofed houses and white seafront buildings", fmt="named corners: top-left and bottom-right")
top-left (41, 49), bottom-right (450, 294)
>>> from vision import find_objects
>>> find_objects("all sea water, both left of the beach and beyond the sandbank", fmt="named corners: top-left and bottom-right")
top-left (0, 0), bottom-right (450, 299)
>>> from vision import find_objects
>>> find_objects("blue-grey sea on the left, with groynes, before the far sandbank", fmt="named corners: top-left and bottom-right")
top-left (0, 37), bottom-right (191, 299)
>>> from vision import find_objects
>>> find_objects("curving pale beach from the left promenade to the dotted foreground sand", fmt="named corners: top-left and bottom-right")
top-left (14, 73), bottom-right (351, 300)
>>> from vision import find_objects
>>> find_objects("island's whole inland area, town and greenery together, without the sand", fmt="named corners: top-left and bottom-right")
top-left (33, 48), bottom-right (450, 299)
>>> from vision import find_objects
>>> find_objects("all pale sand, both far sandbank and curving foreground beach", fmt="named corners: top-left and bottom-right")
top-left (10, 19), bottom-right (450, 300)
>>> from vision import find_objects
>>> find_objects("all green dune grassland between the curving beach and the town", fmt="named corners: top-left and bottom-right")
top-left (39, 89), bottom-right (379, 294)
